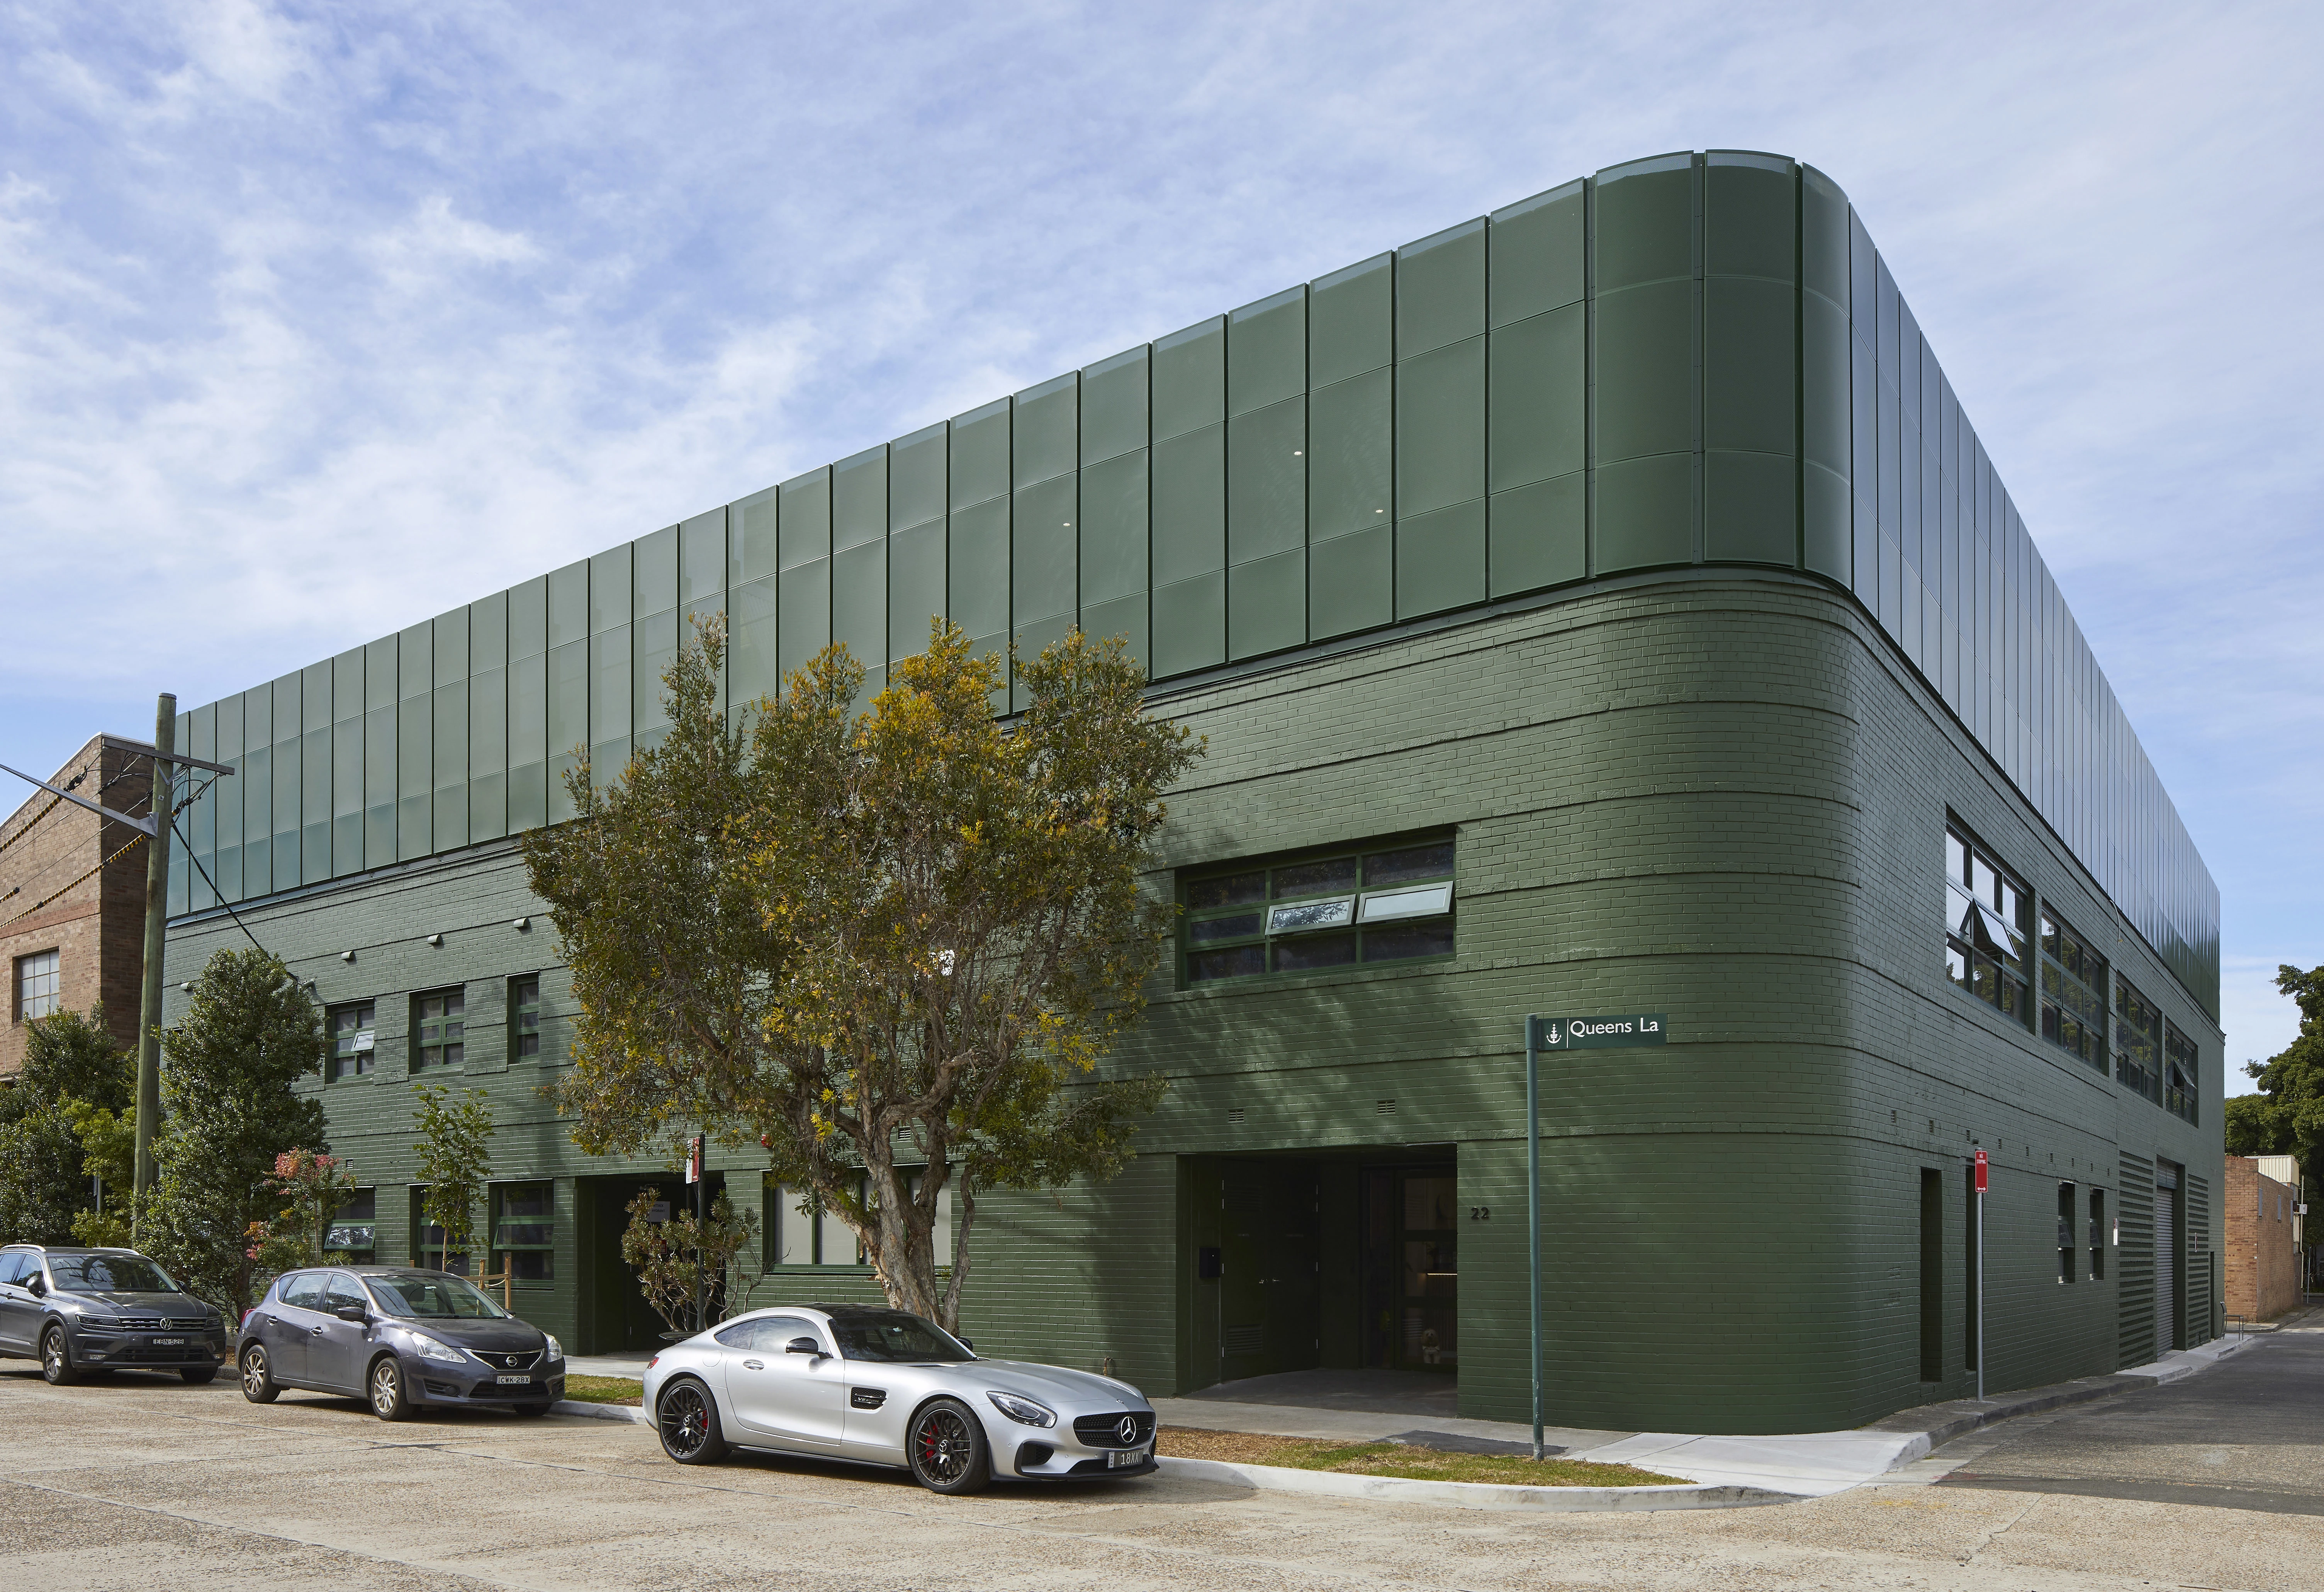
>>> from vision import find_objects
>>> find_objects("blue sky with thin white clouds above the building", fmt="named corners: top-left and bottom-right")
top-left (0, 0), bottom-right (2324, 1092)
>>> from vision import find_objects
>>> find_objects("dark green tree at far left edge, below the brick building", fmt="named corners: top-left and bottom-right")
top-left (0, 1006), bottom-right (135, 1244)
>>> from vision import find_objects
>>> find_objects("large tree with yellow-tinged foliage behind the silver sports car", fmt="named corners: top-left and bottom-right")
top-left (525, 620), bottom-right (1199, 1327)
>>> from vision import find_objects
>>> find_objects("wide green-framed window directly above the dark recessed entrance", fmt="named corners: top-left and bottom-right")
top-left (1178, 834), bottom-right (1453, 983)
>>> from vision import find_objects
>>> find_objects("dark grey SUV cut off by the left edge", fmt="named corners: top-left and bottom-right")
top-left (0, 1244), bottom-right (226, 1385)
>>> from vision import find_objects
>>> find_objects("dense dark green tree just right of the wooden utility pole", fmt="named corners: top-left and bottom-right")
top-left (137, 951), bottom-right (325, 1320)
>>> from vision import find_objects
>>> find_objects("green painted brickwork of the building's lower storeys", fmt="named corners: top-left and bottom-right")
top-left (170, 572), bottom-right (2224, 1432)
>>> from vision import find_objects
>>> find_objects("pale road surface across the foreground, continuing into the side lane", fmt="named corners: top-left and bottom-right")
top-left (0, 1336), bottom-right (2324, 1592)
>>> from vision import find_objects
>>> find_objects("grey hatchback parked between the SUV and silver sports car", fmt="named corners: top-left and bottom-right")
top-left (235, 1267), bottom-right (565, 1420)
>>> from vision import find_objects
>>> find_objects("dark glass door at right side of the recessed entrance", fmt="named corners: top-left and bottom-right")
top-left (1362, 1167), bottom-right (1460, 1371)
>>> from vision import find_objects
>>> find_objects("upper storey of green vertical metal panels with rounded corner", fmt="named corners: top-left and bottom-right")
top-left (170, 151), bottom-right (2219, 1013)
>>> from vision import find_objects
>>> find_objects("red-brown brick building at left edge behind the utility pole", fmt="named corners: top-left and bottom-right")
top-left (0, 734), bottom-right (151, 1078)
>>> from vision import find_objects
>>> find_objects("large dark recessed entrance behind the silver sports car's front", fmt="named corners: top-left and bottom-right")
top-left (1178, 1146), bottom-right (1460, 1402)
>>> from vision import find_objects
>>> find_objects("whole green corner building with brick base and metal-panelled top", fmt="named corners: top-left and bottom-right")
top-left (154, 151), bottom-right (2222, 1432)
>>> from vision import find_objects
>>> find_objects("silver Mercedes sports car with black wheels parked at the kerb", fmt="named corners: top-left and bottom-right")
top-left (646, 1304), bottom-right (1155, 1492)
